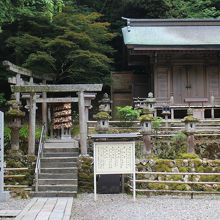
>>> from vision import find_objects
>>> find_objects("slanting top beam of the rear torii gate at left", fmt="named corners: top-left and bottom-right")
top-left (2, 60), bottom-right (53, 81)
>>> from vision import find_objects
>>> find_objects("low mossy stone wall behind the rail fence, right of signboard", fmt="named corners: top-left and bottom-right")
top-left (136, 158), bottom-right (220, 191)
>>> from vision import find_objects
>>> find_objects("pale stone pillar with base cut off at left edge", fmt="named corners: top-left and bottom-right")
top-left (0, 112), bottom-right (9, 202)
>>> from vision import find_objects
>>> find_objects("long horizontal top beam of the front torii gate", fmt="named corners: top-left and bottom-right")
top-left (11, 84), bottom-right (102, 93)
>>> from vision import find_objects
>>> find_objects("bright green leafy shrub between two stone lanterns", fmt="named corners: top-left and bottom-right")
top-left (116, 106), bottom-right (140, 121)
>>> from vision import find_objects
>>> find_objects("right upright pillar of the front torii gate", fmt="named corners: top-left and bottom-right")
top-left (78, 91), bottom-right (87, 155)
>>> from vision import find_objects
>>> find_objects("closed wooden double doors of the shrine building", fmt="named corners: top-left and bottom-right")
top-left (173, 65), bottom-right (206, 104)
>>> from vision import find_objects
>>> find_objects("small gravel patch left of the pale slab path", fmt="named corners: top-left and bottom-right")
top-left (0, 198), bottom-right (30, 210)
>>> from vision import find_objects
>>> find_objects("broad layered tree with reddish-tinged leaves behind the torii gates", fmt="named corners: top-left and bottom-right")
top-left (0, 8), bottom-right (115, 84)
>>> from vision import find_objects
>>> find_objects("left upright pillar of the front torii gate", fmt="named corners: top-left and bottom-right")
top-left (28, 93), bottom-right (36, 155)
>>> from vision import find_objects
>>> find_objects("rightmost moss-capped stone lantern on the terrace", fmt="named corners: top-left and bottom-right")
top-left (183, 108), bottom-right (199, 153)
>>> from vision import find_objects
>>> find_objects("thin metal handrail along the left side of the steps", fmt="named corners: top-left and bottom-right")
top-left (35, 125), bottom-right (46, 192)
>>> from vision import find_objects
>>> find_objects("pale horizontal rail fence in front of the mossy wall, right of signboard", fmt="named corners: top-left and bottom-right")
top-left (129, 172), bottom-right (220, 198)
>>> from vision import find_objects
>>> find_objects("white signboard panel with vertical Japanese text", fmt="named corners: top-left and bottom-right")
top-left (94, 142), bottom-right (135, 174)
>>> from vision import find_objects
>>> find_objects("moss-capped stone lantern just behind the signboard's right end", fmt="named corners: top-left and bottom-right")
top-left (139, 108), bottom-right (154, 155)
